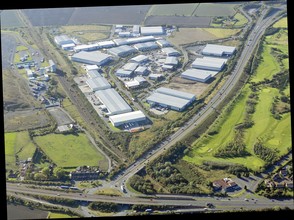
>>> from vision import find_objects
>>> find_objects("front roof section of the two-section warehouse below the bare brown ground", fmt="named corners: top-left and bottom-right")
top-left (147, 92), bottom-right (189, 109)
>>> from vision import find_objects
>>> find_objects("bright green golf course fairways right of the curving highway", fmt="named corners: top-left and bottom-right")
top-left (183, 23), bottom-right (292, 171)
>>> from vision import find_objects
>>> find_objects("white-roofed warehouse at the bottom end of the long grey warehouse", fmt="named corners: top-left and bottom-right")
top-left (109, 111), bottom-right (146, 127)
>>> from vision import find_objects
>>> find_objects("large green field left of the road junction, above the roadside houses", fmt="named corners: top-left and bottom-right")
top-left (35, 133), bottom-right (104, 168)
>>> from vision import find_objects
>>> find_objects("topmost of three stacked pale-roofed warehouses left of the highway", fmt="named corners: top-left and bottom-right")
top-left (202, 44), bottom-right (236, 57)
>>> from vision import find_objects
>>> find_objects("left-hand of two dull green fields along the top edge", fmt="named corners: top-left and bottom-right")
top-left (148, 3), bottom-right (199, 16)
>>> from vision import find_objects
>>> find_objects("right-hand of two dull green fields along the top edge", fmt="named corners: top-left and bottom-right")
top-left (193, 3), bottom-right (240, 17)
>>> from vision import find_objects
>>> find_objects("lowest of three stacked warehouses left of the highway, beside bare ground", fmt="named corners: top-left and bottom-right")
top-left (181, 69), bottom-right (218, 82)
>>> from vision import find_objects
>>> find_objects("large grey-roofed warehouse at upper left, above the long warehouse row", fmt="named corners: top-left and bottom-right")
top-left (71, 51), bottom-right (112, 66)
